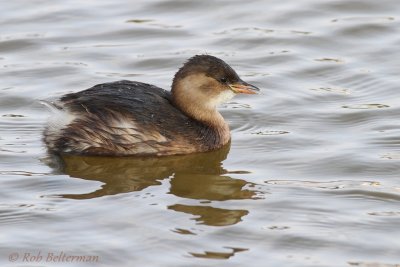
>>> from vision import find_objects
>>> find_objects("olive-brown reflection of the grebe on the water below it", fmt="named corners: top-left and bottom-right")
top-left (51, 144), bottom-right (257, 226)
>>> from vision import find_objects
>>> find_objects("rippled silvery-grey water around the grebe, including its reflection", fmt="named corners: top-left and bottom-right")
top-left (0, 0), bottom-right (400, 267)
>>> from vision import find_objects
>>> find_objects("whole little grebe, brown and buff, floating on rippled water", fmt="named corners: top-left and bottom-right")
top-left (44, 55), bottom-right (259, 156)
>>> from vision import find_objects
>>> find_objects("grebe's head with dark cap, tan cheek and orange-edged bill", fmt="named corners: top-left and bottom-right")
top-left (172, 55), bottom-right (259, 117)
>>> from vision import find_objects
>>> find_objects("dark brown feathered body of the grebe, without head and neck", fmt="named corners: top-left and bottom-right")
top-left (44, 81), bottom-right (225, 156)
